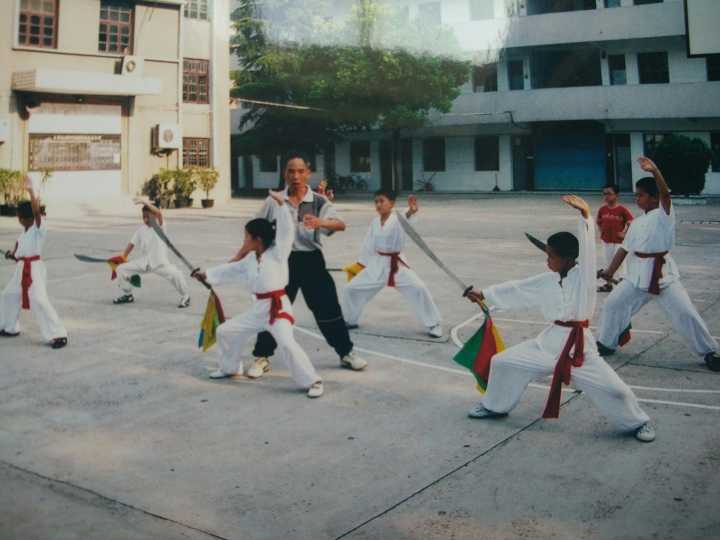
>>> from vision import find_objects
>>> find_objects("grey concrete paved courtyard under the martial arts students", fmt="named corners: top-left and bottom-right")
top-left (0, 195), bottom-right (720, 540)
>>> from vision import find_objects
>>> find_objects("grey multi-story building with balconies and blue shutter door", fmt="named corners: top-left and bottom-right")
top-left (231, 0), bottom-right (720, 193)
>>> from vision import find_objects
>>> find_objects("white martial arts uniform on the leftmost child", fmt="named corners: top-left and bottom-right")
top-left (0, 220), bottom-right (67, 341)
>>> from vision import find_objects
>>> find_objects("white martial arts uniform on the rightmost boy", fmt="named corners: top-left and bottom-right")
top-left (599, 205), bottom-right (718, 355)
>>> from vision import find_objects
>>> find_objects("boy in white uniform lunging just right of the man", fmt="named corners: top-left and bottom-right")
top-left (343, 189), bottom-right (443, 338)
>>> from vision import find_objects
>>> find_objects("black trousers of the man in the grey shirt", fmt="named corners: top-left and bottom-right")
top-left (253, 250), bottom-right (353, 358)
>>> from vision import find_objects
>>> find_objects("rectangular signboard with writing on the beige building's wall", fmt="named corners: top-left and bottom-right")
top-left (28, 133), bottom-right (121, 171)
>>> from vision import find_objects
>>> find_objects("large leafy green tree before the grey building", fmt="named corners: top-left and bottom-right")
top-left (232, 0), bottom-right (470, 189)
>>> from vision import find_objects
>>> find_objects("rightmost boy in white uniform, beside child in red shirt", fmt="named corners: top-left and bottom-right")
top-left (597, 157), bottom-right (720, 371)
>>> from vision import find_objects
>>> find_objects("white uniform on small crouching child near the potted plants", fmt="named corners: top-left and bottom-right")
top-left (116, 223), bottom-right (188, 297)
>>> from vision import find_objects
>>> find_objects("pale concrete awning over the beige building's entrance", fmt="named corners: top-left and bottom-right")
top-left (12, 68), bottom-right (162, 96)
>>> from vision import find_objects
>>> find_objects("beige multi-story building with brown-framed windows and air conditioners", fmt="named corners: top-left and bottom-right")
top-left (0, 0), bottom-right (230, 211)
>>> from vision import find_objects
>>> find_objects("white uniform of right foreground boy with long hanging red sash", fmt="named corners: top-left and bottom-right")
top-left (481, 218), bottom-right (649, 430)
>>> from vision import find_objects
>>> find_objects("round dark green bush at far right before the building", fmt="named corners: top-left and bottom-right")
top-left (652, 135), bottom-right (712, 195)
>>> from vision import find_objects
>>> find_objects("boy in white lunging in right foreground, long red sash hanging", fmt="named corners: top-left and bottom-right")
top-left (468, 195), bottom-right (655, 442)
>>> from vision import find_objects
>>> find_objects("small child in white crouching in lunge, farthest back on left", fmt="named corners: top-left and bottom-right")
top-left (113, 198), bottom-right (190, 308)
